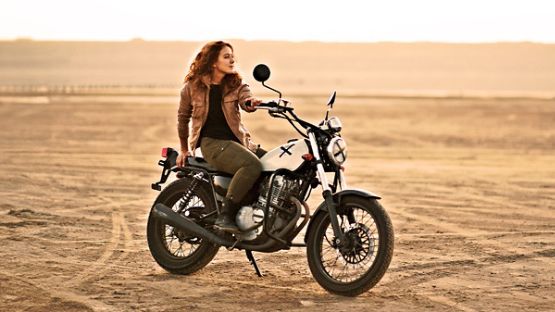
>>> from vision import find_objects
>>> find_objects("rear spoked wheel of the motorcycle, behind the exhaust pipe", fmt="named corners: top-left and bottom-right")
top-left (147, 178), bottom-right (219, 274)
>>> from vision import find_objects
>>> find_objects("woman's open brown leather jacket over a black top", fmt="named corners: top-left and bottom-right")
top-left (177, 77), bottom-right (258, 154)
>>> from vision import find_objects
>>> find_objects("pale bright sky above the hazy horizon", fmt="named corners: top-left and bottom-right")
top-left (4, 0), bottom-right (555, 43)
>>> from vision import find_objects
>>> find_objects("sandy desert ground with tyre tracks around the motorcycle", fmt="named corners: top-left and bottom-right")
top-left (0, 90), bottom-right (555, 311)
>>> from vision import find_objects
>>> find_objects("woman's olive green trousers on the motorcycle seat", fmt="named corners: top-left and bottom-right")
top-left (200, 137), bottom-right (262, 203)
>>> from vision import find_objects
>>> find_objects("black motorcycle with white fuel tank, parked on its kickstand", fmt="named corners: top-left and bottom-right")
top-left (147, 64), bottom-right (394, 296)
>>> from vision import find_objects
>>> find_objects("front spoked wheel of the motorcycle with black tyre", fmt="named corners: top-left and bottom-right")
top-left (307, 196), bottom-right (394, 296)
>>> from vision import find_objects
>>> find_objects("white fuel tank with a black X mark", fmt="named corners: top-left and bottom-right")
top-left (260, 140), bottom-right (308, 171)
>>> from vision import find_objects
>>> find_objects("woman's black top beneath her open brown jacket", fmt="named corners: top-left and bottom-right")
top-left (199, 84), bottom-right (241, 145)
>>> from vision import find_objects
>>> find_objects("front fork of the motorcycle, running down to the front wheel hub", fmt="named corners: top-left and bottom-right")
top-left (308, 131), bottom-right (347, 245)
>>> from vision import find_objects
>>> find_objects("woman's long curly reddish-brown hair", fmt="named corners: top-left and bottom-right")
top-left (185, 41), bottom-right (242, 89)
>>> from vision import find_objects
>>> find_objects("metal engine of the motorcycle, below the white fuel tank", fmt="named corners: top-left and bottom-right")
top-left (236, 175), bottom-right (301, 240)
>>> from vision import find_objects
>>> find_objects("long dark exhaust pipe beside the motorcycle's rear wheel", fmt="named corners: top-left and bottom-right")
top-left (151, 204), bottom-right (234, 247)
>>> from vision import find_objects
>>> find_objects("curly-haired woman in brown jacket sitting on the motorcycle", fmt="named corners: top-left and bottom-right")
top-left (177, 41), bottom-right (262, 233)
